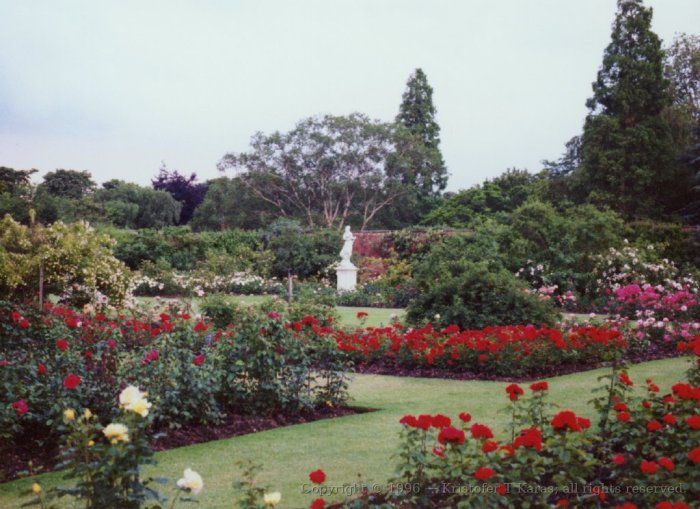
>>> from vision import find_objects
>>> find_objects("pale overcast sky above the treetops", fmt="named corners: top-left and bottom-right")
top-left (0, 0), bottom-right (700, 190)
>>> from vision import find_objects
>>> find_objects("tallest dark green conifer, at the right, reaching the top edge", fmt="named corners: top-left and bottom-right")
top-left (574, 0), bottom-right (679, 219)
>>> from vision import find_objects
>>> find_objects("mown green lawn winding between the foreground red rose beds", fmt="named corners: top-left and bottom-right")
top-left (0, 359), bottom-right (688, 509)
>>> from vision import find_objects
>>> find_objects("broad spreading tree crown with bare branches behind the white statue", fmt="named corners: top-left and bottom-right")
top-left (219, 113), bottom-right (420, 229)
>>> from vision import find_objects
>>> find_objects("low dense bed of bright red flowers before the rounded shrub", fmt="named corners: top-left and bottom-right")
top-left (336, 323), bottom-right (628, 376)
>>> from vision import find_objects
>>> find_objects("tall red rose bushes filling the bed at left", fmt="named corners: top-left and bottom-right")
top-left (0, 303), bottom-right (348, 466)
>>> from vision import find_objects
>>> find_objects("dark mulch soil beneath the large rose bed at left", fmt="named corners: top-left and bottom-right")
top-left (0, 407), bottom-right (370, 482)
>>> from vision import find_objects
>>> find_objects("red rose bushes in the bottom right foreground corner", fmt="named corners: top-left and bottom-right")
top-left (331, 359), bottom-right (700, 509)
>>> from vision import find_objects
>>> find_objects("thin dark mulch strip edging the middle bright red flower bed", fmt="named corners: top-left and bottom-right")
top-left (354, 345), bottom-right (680, 382)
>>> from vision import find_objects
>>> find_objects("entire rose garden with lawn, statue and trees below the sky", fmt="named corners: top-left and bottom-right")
top-left (0, 0), bottom-right (700, 509)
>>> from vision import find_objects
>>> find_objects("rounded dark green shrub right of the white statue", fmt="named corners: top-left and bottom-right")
top-left (407, 237), bottom-right (558, 328)
